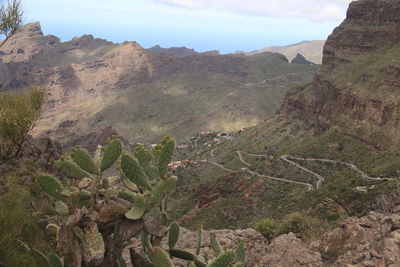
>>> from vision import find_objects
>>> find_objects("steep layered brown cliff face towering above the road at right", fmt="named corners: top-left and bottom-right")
top-left (281, 0), bottom-right (400, 148)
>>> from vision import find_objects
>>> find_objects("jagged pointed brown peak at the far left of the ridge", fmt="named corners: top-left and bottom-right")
top-left (0, 22), bottom-right (60, 63)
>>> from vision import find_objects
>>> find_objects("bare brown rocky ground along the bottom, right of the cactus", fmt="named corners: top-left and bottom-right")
top-left (126, 210), bottom-right (400, 267)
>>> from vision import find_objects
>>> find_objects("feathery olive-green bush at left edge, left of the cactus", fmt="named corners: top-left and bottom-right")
top-left (0, 87), bottom-right (44, 163)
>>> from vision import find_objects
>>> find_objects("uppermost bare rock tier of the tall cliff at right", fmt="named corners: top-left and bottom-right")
top-left (323, 0), bottom-right (400, 65)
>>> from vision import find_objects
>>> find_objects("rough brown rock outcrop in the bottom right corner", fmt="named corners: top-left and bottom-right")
top-left (310, 212), bottom-right (400, 266)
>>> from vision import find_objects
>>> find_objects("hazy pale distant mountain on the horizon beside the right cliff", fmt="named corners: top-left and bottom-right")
top-left (247, 40), bottom-right (325, 64)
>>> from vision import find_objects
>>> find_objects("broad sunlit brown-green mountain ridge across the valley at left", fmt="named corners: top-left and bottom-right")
top-left (0, 23), bottom-right (318, 150)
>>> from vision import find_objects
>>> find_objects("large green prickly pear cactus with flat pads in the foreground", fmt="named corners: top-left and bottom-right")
top-left (37, 137), bottom-right (179, 266)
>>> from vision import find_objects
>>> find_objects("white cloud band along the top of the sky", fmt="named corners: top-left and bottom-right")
top-left (153, 0), bottom-right (351, 21)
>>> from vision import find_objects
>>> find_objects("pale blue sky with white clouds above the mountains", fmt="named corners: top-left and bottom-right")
top-left (22, 0), bottom-right (351, 53)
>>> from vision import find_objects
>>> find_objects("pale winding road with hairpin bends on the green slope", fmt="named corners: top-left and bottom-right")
top-left (201, 149), bottom-right (396, 191)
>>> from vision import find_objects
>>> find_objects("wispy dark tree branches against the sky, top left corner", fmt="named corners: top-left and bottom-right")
top-left (0, 0), bottom-right (24, 48)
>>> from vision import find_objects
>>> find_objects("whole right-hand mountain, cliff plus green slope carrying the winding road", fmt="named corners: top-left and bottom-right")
top-left (170, 0), bottom-right (400, 235)
